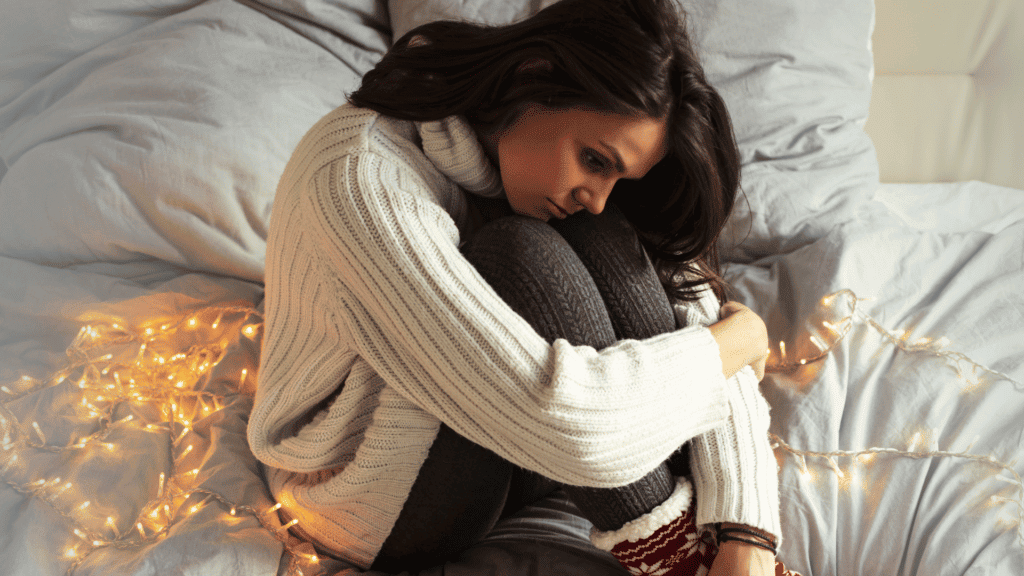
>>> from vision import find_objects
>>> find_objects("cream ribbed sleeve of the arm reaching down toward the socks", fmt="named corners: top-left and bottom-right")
top-left (692, 366), bottom-right (782, 542)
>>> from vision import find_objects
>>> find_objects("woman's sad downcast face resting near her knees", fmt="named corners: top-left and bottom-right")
top-left (497, 105), bottom-right (666, 221)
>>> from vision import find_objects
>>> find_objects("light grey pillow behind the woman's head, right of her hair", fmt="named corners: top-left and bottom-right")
top-left (388, 0), bottom-right (879, 261)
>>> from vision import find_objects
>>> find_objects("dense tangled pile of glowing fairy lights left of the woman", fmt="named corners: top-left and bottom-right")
top-left (0, 306), bottom-right (321, 576)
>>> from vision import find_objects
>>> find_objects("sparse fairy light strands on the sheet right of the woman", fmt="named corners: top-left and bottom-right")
top-left (766, 290), bottom-right (1024, 549)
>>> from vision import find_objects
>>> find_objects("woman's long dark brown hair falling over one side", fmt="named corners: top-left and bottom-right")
top-left (348, 0), bottom-right (739, 300)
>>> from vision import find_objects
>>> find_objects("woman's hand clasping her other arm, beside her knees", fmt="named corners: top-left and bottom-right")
top-left (708, 302), bottom-right (769, 380)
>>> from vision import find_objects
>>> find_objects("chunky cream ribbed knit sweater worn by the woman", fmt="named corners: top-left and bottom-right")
top-left (249, 105), bottom-right (780, 568)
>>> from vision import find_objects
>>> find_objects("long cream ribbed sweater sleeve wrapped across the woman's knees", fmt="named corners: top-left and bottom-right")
top-left (305, 152), bottom-right (728, 487)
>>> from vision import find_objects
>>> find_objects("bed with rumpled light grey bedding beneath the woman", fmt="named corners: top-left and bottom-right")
top-left (0, 0), bottom-right (1024, 576)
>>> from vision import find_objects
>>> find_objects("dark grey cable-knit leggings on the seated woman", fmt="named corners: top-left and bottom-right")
top-left (373, 204), bottom-right (688, 572)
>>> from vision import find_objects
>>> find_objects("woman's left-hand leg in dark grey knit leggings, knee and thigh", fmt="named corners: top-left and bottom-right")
top-left (373, 211), bottom-right (643, 572)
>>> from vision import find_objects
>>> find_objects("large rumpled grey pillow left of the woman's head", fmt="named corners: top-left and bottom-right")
top-left (0, 0), bottom-right (390, 281)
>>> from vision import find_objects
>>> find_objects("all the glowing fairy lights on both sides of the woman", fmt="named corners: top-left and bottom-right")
top-left (0, 290), bottom-right (1024, 576)
